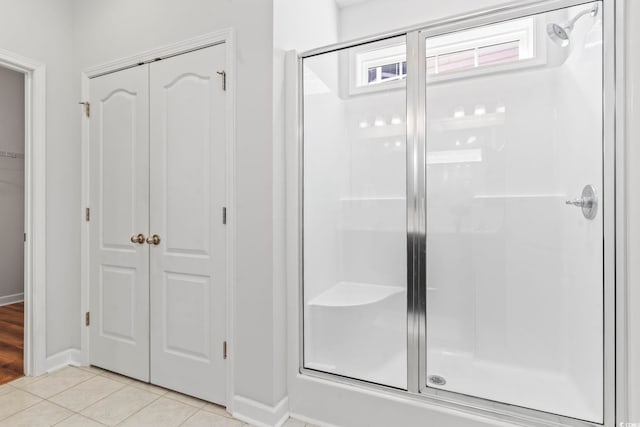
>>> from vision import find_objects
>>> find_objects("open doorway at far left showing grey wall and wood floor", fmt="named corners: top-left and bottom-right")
top-left (0, 67), bottom-right (25, 384)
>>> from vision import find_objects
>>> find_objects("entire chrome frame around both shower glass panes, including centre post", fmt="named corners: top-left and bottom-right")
top-left (297, 0), bottom-right (627, 427)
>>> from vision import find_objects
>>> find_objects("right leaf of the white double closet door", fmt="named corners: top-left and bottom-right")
top-left (150, 45), bottom-right (226, 404)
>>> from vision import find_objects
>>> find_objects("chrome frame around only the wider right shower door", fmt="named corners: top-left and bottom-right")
top-left (407, 0), bottom-right (616, 426)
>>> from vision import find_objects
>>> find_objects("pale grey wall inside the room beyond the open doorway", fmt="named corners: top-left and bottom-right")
top-left (0, 68), bottom-right (24, 304)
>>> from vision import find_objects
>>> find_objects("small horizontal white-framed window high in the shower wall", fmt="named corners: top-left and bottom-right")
top-left (349, 16), bottom-right (547, 95)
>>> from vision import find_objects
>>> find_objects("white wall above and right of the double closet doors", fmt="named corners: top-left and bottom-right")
top-left (73, 0), bottom-right (286, 414)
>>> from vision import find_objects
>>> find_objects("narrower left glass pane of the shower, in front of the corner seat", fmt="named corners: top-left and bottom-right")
top-left (303, 37), bottom-right (407, 388)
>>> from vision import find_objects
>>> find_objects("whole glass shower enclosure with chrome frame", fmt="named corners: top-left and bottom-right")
top-left (300, 1), bottom-right (614, 425)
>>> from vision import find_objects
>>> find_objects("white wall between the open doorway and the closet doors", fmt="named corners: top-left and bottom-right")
top-left (0, 0), bottom-right (80, 362)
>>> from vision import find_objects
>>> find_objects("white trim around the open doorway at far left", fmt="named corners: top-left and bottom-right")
top-left (0, 49), bottom-right (47, 375)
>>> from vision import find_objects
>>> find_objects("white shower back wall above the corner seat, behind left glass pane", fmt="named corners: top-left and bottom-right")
top-left (340, 91), bottom-right (406, 289)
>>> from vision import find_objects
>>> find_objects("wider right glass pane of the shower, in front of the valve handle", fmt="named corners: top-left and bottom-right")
top-left (424, 4), bottom-right (609, 422)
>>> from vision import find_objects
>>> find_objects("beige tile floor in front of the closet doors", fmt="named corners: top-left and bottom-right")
top-left (0, 366), bottom-right (313, 427)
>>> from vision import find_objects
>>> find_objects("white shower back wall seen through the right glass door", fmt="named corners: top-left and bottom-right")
top-left (427, 66), bottom-right (566, 368)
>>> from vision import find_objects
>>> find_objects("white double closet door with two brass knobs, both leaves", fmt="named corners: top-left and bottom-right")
top-left (90, 45), bottom-right (226, 404)
